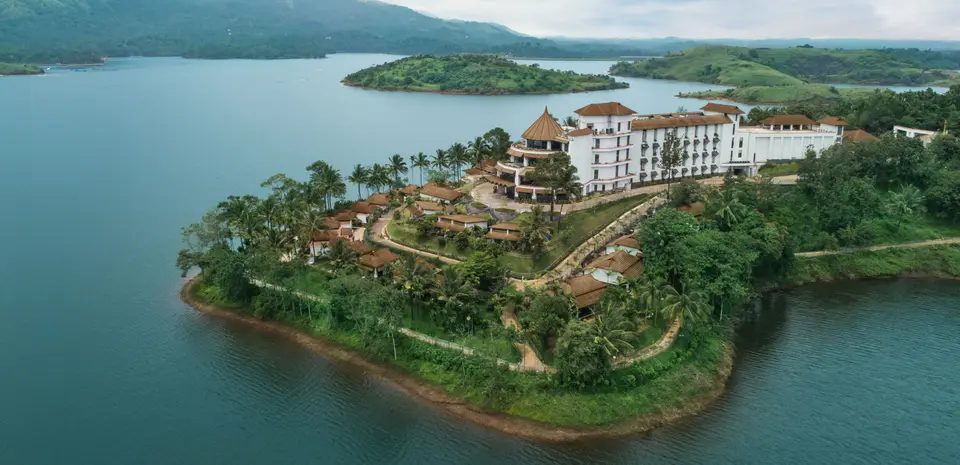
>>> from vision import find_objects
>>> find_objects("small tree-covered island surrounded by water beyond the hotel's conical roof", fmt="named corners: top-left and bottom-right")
top-left (343, 55), bottom-right (630, 95)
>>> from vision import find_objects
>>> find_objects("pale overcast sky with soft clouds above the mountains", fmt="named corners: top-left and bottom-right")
top-left (386, 0), bottom-right (960, 40)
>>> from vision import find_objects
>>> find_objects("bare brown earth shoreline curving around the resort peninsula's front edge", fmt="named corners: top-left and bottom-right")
top-left (180, 276), bottom-right (734, 442)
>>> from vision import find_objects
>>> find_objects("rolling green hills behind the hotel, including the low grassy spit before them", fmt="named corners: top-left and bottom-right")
top-left (610, 45), bottom-right (960, 104)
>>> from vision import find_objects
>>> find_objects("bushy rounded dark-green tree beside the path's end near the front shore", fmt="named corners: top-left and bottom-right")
top-left (555, 320), bottom-right (610, 390)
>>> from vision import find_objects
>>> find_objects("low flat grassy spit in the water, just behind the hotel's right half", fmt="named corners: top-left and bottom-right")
top-left (678, 84), bottom-right (874, 105)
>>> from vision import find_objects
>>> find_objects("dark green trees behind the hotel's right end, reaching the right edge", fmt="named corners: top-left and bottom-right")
top-left (747, 85), bottom-right (960, 135)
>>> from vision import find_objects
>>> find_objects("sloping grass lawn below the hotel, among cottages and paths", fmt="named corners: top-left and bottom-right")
top-left (388, 195), bottom-right (650, 273)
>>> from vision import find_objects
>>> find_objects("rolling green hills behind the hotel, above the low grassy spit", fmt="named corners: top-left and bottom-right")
top-left (610, 45), bottom-right (960, 87)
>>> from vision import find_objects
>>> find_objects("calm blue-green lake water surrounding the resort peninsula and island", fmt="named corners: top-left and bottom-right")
top-left (0, 55), bottom-right (960, 465)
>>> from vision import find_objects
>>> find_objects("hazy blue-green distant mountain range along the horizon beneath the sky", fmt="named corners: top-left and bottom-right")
top-left (0, 0), bottom-right (960, 63)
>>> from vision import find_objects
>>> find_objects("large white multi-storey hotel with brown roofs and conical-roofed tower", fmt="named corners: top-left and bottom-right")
top-left (496, 102), bottom-right (846, 198)
